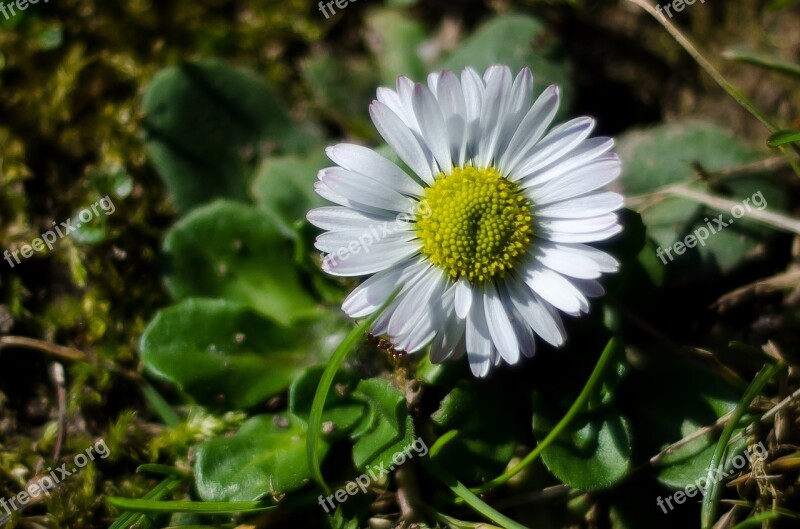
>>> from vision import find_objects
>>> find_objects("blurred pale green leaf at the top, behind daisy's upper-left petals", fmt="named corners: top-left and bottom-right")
top-left (366, 9), bottom-right (426, 87)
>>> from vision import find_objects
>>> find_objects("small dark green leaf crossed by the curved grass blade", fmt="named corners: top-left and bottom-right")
top-left (289, 366), bottom-right (366, 436)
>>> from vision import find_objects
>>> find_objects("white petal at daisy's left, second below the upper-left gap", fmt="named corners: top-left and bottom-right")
top-left (318, 167), bottom-right (417, 213)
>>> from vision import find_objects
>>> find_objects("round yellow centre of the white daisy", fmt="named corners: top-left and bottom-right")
top-left (417, 166), bottom-right (533, 283)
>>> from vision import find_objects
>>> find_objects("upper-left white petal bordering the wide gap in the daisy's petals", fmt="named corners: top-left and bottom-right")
top-left (369, 101), bottom-right (434, 184)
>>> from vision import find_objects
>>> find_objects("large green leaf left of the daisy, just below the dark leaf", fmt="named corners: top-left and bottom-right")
top-left (164, 201), bottom-right (318, 324)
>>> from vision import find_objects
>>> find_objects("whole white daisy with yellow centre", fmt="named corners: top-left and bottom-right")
top-left (308, 66), bottom-right (623, 377)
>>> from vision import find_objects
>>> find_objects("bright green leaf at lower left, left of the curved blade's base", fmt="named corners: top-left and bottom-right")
top-left (194, 415), bottom-right (327, 501)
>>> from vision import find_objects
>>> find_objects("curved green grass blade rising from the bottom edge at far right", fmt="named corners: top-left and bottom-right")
top-left (700, 362), bottom-right (784, 529)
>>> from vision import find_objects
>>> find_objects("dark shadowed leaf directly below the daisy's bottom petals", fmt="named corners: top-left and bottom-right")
top-left (431, 380), bottom-right (524, 482)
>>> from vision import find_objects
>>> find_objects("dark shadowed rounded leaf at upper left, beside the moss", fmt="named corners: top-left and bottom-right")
top-left (142, 61), bottom-right (294, 211)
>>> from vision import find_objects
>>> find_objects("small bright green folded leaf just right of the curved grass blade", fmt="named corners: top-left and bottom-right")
top-left (352, 378), bottom-right (414, 470)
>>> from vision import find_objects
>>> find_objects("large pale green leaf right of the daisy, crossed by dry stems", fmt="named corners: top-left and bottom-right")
top-left (619, 122), bottom-right (785, 274)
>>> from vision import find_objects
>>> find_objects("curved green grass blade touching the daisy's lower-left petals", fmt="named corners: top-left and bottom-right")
top-left (306, 289), bottom-right (399, 494)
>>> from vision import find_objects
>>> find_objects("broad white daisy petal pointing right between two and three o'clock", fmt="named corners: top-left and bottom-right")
top-left (527, 153), bottom-right (622, 207)
